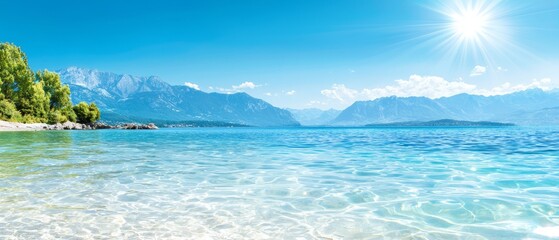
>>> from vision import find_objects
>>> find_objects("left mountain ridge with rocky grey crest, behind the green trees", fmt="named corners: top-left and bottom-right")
top-left (58, 67), bottom-right (299, 126)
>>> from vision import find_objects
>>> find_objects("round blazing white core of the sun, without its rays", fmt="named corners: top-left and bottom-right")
top-left (452, 10), bottom-right (487, 39)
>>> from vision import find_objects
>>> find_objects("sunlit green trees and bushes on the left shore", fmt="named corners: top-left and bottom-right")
top-left (0, 43), bottom-right (100, 123)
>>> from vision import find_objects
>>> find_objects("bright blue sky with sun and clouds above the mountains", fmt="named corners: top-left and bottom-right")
top-left (0, 0), bottom-right (559, 109)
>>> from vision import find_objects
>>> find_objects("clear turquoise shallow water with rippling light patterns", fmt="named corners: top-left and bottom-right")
top-left (0, 127), bottom-right (559, 240)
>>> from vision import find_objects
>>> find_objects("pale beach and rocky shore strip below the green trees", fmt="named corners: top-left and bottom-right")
top-left (0, 121), bottom-right (158, 131)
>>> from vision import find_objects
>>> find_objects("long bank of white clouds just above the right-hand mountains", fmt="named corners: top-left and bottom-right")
top-left (320, 75), bottom-right (559, 102)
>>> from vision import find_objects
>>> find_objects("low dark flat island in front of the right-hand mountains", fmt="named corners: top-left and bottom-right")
top-left (365, 119), bottom-right (515, 128)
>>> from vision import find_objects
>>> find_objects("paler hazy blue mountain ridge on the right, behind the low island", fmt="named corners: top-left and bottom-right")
top-left (330, 89), bottom-right (559, 125)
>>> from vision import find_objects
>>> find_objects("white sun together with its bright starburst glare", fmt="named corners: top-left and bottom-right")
top-left (418, 0), bottom-right (519, 65)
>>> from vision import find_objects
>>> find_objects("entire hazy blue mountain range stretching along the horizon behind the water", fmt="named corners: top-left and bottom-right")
top-left (58, 67), bottom-right (559, 126)
